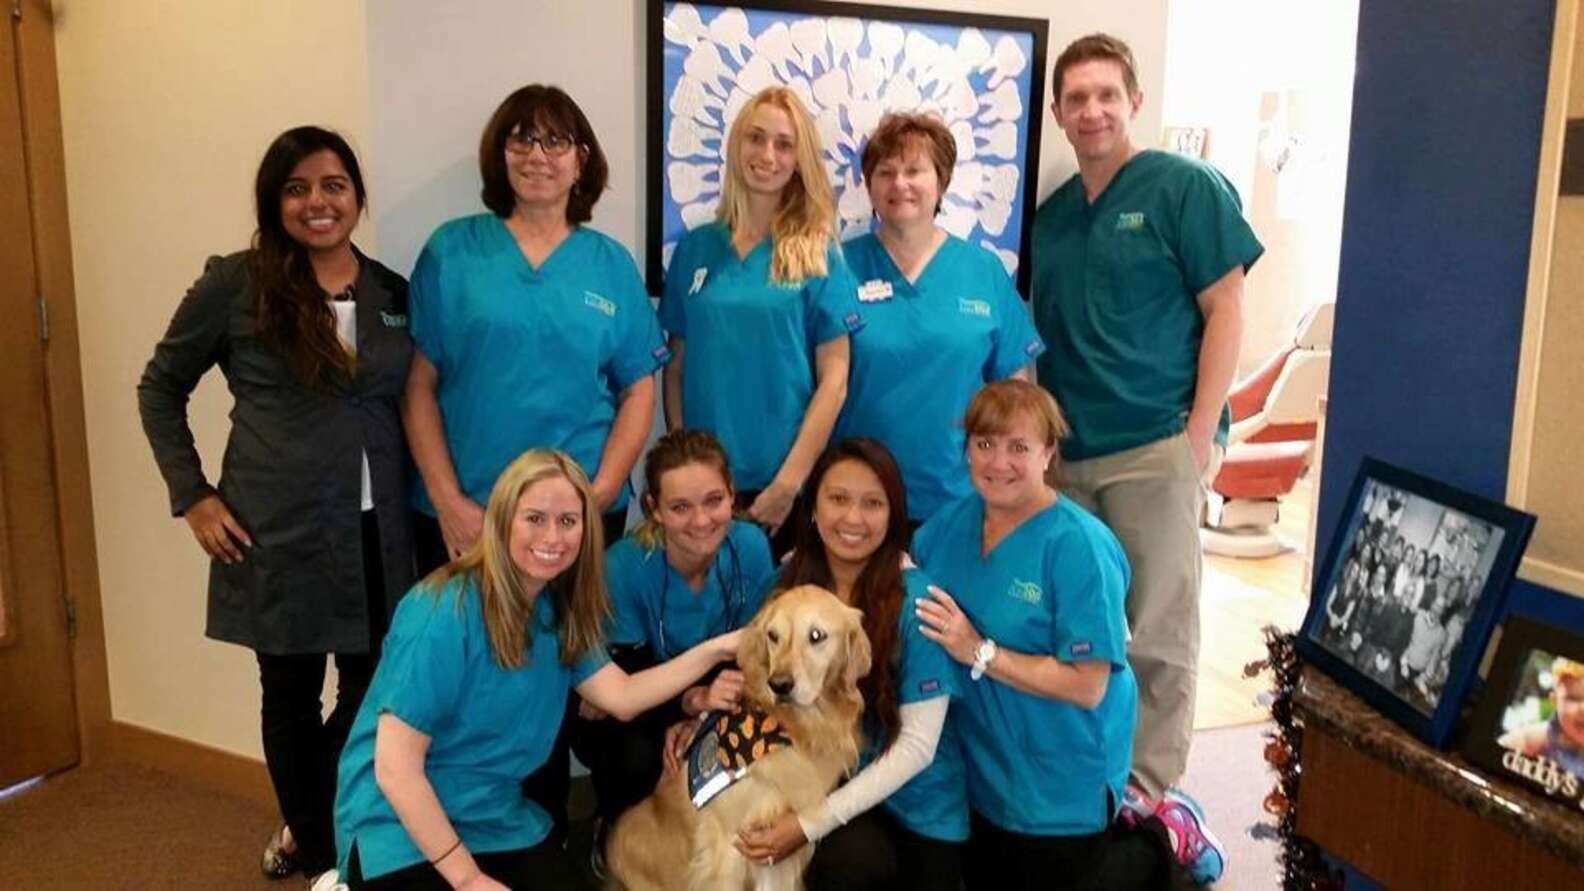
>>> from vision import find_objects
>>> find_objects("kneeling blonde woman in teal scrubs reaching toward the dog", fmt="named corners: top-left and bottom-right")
top-left (336, 449), bottom-right (737, 889)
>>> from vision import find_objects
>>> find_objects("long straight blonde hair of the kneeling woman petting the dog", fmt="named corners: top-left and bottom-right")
top-left (423, 449), bottom-right (610, 669)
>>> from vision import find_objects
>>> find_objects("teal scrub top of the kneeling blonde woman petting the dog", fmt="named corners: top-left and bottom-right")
top-left (336, 576), bottom-right (608, 877)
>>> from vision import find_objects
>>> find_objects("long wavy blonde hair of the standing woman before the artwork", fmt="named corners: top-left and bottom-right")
top-left (719, 87), bottom-right (836, 284)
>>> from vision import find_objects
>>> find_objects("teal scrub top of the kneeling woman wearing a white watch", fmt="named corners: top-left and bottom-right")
top-left (912, 495), bottom-right (1139, 836)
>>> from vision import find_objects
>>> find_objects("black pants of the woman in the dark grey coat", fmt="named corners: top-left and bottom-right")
top-left (255, 511), bottom-right (386, 875)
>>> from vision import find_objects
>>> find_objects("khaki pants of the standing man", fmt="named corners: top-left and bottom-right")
top-left (1047, 434), bottom-right (1221, 797)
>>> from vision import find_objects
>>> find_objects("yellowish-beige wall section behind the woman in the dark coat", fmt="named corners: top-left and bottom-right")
top-left (55, 0), bottom-right (372, 755)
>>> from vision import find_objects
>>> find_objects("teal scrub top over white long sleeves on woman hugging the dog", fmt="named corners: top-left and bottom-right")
top-left (860, 569), bottom-right (968, 842)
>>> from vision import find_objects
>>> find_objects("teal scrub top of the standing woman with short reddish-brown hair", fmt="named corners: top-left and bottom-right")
top-left (835, 235), bottom-right (1045, 520)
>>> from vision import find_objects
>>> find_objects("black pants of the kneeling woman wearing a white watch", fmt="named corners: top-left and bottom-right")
top-left (963, 813), bottom-right (1174, 891)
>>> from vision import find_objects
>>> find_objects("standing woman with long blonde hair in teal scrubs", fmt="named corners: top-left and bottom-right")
top-left (661, 87), bottom-right (862, 556)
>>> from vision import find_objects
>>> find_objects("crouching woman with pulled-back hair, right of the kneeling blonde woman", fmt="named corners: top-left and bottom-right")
top-left (572, 430), bottom-right (775, 856)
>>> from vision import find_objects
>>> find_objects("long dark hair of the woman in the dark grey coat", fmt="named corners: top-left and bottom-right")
top-left (250, 127), bottom-right (366, 388)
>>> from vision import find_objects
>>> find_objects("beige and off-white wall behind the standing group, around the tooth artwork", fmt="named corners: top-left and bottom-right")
top-left (55, 0), bottom-right (1166, 756)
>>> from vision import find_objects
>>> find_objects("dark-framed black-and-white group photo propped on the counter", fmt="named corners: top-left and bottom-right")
top-left (1297, 458), bottom-right (1535, 748)
